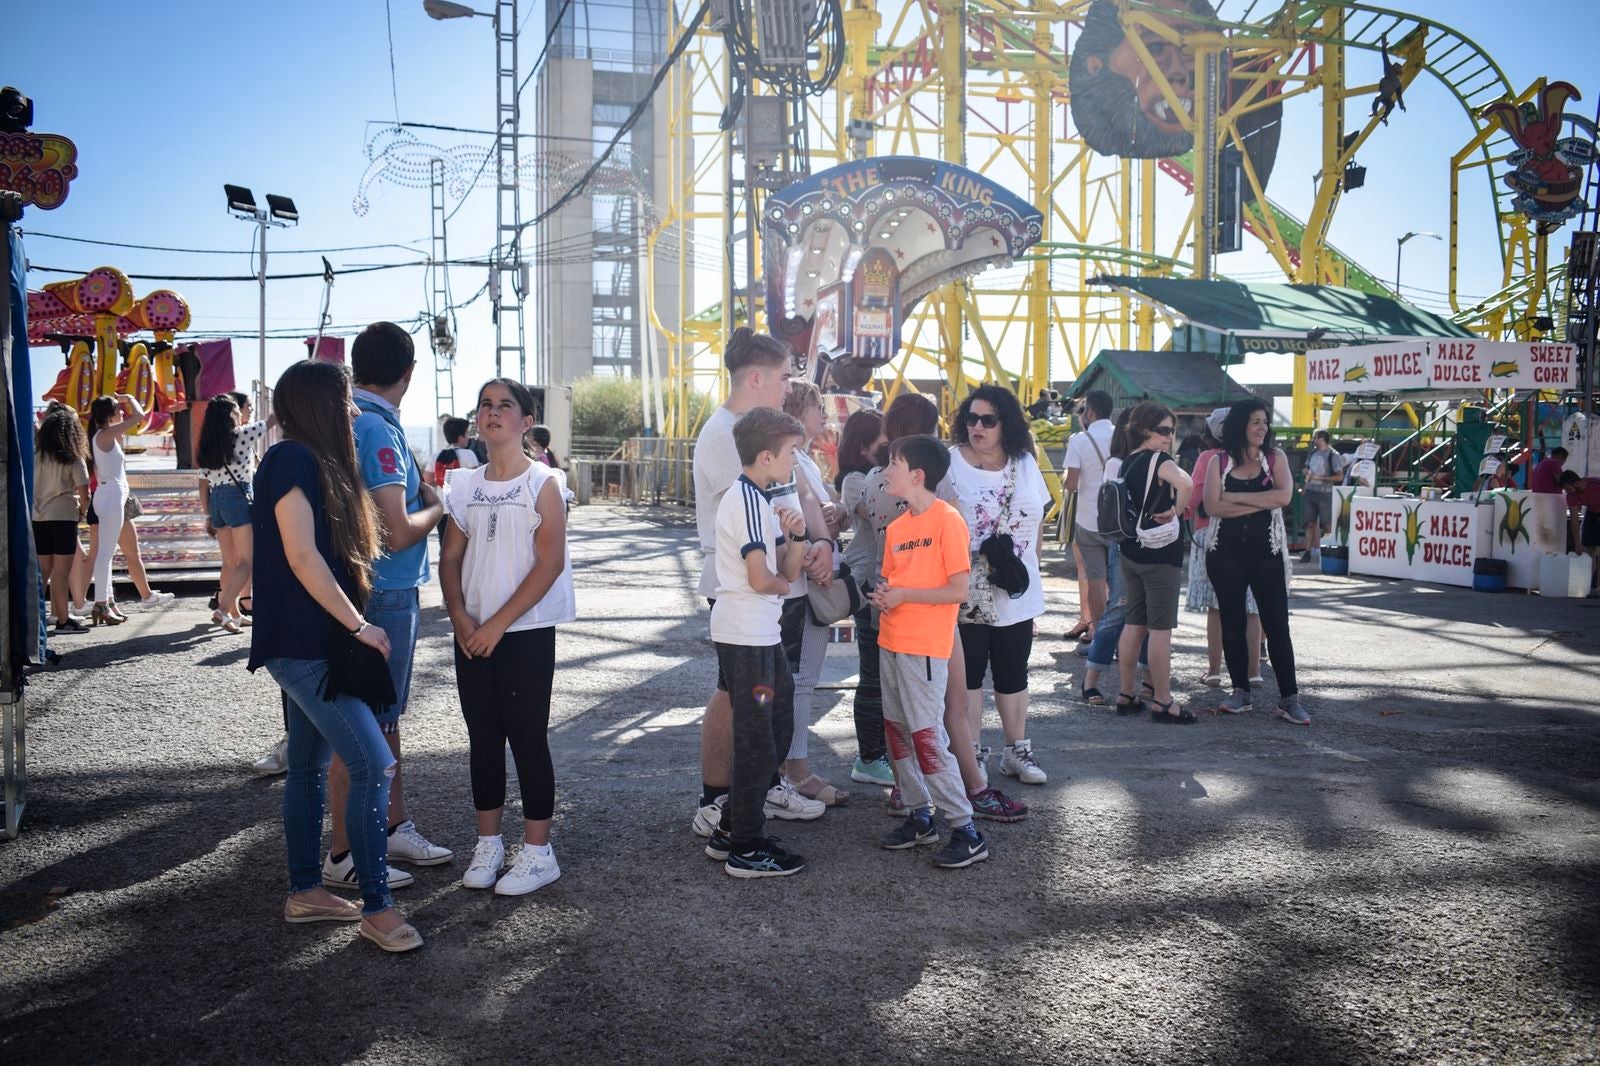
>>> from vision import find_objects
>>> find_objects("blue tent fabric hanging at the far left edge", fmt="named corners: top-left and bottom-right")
top-left (0, 224), bottom-right (46, 677)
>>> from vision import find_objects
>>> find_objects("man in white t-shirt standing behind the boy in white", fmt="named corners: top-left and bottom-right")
top-left (693, 327), bottom-right (834, 837)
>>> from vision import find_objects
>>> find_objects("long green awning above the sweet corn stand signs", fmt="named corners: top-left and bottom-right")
top-left (1090, 275), bottom-right (1475, 359)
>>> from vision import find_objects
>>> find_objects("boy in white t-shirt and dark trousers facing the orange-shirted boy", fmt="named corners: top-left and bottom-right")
top-left (706, 407), bottom-right (810, 877)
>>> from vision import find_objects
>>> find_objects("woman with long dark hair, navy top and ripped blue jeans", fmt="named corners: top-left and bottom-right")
top-left (248, 360), bottom-right (422, 951)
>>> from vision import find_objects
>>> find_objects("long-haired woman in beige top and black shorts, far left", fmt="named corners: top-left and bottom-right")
top-left (34, 403), bottom-right (90, 632)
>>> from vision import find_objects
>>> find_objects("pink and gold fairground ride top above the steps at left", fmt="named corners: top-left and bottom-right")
top-left (27, 267), bottom-right (190, 434)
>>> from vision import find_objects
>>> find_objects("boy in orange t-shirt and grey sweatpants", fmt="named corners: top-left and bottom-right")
top-left (872, 435), bottom-right (989, 869)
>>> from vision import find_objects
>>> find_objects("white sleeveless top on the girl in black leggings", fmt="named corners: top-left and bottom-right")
top-left (443, 463), bottom-right (578, 632)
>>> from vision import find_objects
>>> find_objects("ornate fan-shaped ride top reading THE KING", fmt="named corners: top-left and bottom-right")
top-left (762, 155), bottom-right (1043, 392)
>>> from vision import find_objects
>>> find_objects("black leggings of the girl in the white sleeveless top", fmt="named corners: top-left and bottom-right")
top-left (454, 626), bottom-right (555, 821)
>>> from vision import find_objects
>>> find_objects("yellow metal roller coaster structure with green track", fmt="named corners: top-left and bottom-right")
top-left (645, 0), bottom-right (1558, 437)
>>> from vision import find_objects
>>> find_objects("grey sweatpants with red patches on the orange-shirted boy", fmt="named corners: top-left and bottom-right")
top-left (878, 647), bottom-right (973, 826)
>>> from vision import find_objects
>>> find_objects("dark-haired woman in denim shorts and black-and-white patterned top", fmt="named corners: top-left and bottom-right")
top-left (195, 394), bottom-right (275, 632)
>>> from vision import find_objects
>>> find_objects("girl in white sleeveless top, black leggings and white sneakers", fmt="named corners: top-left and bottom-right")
top-left (438, 378), bottom-right (578, 896)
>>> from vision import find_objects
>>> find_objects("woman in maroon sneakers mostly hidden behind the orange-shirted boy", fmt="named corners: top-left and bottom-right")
top-left (861, 392), bottom-right (1027, 821)
